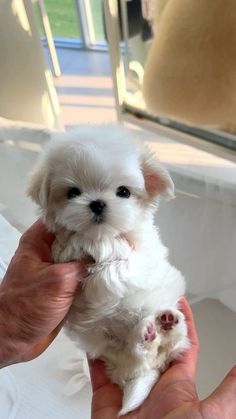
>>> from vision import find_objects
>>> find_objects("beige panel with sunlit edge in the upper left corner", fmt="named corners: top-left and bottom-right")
top-left (0, 0), bottom-right (59, 128)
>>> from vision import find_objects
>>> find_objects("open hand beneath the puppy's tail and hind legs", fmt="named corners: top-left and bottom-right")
top-left (89, 299), bottom-right (236, 419)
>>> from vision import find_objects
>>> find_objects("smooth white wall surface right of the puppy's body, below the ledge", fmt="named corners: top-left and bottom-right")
top-left (156, 172), bottom-right (236, 311)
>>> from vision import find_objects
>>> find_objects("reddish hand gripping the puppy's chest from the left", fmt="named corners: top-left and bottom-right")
top-left (0, 221), bottom-right (84, 367)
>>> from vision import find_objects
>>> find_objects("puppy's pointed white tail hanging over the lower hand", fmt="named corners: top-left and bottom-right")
top-left (118, 370), bottom-right (159, 416)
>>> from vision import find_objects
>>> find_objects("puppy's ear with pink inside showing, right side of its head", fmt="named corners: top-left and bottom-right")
top-left (141, 147), bottom-right (175, 199)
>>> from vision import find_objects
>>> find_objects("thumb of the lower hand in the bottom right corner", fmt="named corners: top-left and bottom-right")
top-left (203, 365), bottom-right (236, 419)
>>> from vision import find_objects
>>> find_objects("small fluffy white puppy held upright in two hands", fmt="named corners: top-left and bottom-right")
top-left (28, 125), bottom-right (188, 415)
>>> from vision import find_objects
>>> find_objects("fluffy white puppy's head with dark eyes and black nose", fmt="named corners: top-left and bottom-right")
top-left (28, 125), bottom-right (174, 239)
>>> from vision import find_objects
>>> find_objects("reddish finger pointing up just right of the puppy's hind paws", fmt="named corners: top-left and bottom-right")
top-left (173, 297), bottom-right (199, 378)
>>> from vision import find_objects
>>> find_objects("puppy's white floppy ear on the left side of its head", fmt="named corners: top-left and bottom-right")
top-left (26, 163), bottom-right (49, 208)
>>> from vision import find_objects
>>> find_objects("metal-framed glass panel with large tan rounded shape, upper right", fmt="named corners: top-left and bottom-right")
top-left (106, 0), bottom-right (236, 149)
